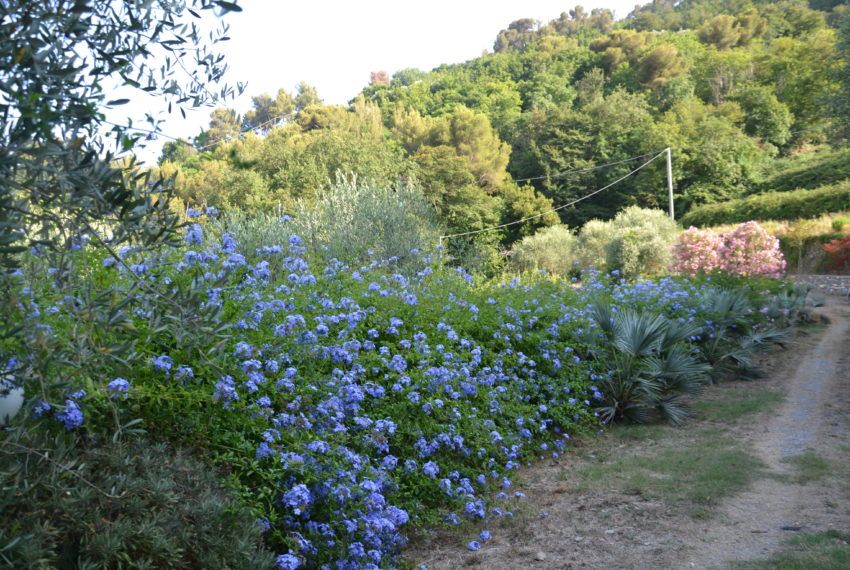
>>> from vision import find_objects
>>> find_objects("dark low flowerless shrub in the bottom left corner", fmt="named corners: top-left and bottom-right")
top-left (0, 426), bottom-right (275, 570)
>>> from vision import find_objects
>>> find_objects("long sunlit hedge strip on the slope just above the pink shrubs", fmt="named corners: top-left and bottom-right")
top-left (681, 182), bottom-right (850, 226)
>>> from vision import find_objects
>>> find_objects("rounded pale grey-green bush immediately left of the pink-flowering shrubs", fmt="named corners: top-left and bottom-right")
top-left (577, 206), bottom-right (679, 277)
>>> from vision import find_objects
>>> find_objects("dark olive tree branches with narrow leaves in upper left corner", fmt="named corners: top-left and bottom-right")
top-left (0, 0), bottom-right (240, 273)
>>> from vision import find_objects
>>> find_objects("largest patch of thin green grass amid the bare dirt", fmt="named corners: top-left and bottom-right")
top-left (575, 430), bottom-right (764, 506)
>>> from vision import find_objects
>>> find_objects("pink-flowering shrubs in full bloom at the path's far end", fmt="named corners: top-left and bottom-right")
top-left (671, 222), bottom-right (785, 277)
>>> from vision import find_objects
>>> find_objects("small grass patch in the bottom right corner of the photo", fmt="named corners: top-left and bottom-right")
top-left (733, 530), bottom-right (850, 570)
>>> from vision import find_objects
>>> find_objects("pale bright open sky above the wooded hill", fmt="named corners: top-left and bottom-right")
top-left (119, 0), bottom-right (644, 162)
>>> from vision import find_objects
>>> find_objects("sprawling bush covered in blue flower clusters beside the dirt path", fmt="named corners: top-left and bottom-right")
top-left (0, 212), bottom-right (796, 568)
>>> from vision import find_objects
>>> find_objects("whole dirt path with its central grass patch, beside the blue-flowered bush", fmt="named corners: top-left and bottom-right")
top-left (408, 293), bottom-right (850, 570)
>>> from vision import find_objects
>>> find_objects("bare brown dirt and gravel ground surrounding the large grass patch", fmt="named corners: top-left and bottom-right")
top-left (410, 296), bottom-right (850, 570)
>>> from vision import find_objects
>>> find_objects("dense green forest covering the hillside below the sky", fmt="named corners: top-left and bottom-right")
top-left (159, 0), bottom-right (850, 244)
